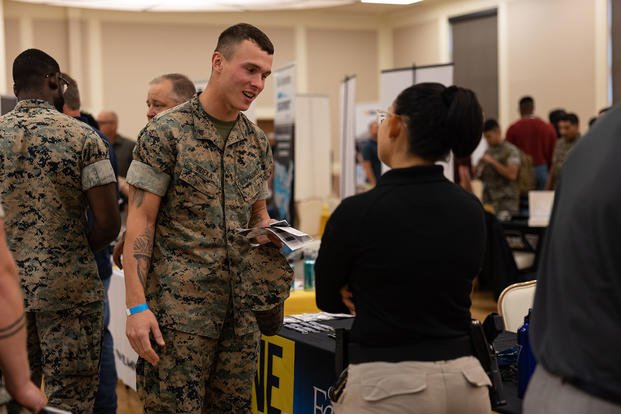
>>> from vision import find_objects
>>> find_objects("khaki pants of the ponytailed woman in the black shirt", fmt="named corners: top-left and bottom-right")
top-left (333, 357), bottom-right (491, 414)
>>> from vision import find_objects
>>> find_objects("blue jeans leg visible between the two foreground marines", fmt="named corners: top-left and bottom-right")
top-left (93, 277), bottom-right (117, 414)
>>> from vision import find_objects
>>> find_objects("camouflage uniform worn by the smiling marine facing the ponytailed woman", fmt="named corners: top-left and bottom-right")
top-left (127, 96), bottom-right (291, 413)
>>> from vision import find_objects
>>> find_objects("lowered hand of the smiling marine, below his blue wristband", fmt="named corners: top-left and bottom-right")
top-left (125, 310), bottom-right (165, 366)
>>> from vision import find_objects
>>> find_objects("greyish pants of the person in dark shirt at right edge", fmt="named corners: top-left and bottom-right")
top-left (524, 365), bottom-right (621, 414)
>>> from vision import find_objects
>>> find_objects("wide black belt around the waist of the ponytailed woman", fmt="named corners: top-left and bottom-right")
top-left (348, 335), bottom-right (474, 364)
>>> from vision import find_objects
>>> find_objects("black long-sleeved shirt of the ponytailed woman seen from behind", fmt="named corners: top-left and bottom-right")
top-left (315, 165), bottom-right (485, 346)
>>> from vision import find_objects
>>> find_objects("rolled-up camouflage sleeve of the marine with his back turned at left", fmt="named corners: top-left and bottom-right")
top-left (82, 131), bottom-right (116, 191)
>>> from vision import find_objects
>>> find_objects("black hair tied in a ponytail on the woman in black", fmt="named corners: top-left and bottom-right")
top-left (395, 83), bottom-right (483, 161)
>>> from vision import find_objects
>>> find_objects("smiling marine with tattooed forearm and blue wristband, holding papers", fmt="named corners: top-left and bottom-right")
top-left (123, 23), bottom-right (291, 413)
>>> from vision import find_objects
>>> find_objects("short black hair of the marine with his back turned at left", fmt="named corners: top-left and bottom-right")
top-left (13, 49), bottom-right (60, 90)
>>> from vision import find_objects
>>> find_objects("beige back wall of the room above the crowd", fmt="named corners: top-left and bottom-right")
top-left (2, 0), bottom-right (608, 155)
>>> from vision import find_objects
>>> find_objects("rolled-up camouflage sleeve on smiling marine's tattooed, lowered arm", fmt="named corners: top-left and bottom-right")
top-left (126, 122), bottom-right (175, 197)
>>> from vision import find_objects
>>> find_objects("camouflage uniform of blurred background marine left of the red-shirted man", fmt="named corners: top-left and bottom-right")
top-left (478, 141), bottom-right (520, 213)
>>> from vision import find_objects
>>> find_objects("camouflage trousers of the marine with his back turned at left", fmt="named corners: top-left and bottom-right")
top-left (26, 302), bottom-right (103, 413)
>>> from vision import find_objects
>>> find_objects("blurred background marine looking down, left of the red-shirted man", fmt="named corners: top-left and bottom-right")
top-left (475, 119), bottom-right (520, 214)
